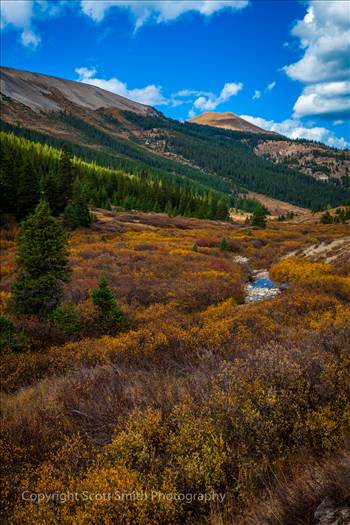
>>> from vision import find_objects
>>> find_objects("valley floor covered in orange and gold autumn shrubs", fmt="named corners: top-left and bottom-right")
top-left (1, 210), bottom-right (350, 525)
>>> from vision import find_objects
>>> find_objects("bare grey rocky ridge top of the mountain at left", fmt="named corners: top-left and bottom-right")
top-left (0, 67), bottom-right (158, 116)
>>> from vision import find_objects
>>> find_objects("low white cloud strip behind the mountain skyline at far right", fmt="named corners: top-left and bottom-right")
top-left (240, 115), bottom-right (348, 149)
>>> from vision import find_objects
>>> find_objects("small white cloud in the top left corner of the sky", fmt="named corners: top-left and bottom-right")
top-left (0, 0), bottom-right (69, 48)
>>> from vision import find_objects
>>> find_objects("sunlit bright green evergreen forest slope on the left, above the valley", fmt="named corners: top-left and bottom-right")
top-left (0, 133), bottom-right (229, 220)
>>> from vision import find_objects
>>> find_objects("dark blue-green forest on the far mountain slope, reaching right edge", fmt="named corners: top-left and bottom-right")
top-left (123, 112), bottom-right (350, 210)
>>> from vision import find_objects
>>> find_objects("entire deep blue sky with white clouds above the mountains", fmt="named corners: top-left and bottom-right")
top-left (1, 0), bottom-right (350, 147)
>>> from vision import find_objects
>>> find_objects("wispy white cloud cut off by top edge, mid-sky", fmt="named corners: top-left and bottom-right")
top-left (80, 0), bottom-right (249, 30)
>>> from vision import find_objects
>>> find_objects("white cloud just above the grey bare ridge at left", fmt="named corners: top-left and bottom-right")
top-left (75, 67), bottom-right (169, 106)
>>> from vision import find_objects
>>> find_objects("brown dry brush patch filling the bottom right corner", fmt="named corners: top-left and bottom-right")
top-left (234, 450), bottom-right (350, 525)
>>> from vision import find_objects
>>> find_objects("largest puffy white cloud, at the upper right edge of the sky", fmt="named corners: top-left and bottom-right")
top-left (283, 0), bottom-right (350, 118)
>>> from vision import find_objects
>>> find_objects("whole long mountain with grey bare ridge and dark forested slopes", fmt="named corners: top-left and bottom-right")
top-left (0, 68), bottom-right (350, 209)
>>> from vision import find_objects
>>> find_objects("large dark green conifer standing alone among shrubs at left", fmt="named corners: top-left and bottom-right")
top-left (12, 200), bottom-right (70, 316)
